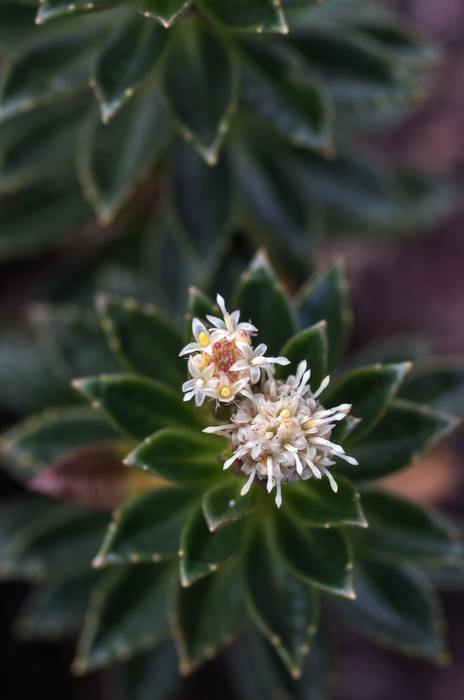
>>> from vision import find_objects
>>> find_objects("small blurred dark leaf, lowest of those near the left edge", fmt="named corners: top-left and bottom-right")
top-left (14, 572), bottom-right (99, 642)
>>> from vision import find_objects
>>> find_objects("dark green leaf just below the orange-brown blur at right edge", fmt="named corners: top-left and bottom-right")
top-left (353, 489), bottom-right (464, 566)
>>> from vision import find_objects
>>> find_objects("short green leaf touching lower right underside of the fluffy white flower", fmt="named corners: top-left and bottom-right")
top-left (285, 474), bottom-right (369, 527)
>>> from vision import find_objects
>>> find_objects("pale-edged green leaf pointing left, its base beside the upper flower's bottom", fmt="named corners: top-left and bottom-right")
top-left (73, 374), bottom-right (199, 440)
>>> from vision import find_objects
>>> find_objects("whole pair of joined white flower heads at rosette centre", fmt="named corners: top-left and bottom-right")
top-left (181, 296), bottom-right (357, 507)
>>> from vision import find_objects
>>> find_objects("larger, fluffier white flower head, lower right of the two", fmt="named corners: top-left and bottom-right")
top-left (204, 361), bottom-right (357, 507)
